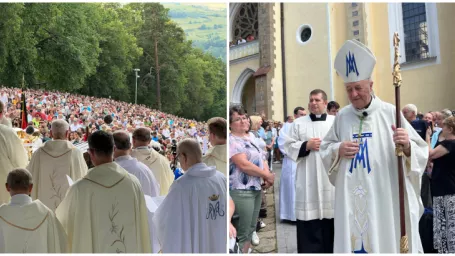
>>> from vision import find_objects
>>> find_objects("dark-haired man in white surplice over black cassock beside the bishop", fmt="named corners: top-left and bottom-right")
top-left (280, 89), bottom-right (335, 253)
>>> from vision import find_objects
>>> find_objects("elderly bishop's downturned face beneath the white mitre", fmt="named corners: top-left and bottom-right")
top-left (345, 80), bottom-right (373, 109)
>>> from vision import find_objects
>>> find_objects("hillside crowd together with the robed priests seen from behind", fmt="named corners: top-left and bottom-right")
top-left (0, 88), bottom-right (227, 253)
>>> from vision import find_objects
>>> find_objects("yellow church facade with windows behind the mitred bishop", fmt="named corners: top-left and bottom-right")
top-left (229, 3), bottom-right (455, 121)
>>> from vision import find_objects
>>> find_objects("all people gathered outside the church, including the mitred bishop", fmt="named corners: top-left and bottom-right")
top-left (229, 40), bottom-right (455, 253)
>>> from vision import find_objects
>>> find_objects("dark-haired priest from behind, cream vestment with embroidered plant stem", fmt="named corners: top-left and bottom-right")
top-left (55, 131), bottom-right (151, 253)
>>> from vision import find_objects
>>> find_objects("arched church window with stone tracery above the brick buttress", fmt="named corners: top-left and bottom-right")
top-left (233, 3), bottom-right (259, 40)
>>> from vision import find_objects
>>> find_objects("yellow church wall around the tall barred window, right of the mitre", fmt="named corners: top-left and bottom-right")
top-left (369, 3), bottom-right (455, 113)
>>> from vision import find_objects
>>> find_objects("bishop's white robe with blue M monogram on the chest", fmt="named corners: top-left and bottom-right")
top-left (321, 97), bottom-right (428, 253)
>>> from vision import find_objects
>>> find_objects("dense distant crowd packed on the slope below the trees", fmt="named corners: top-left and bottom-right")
top-left (0, 87), bottom-right (209, 162)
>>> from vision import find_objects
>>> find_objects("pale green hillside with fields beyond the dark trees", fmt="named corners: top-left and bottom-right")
top-left (162, 3), bottom-right (227, 62)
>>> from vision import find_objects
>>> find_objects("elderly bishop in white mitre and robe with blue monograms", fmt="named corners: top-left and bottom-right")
top-left (320, 40), bottom-right (428, 253)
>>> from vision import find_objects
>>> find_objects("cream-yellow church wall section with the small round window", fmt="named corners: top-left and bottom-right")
top-left (284, 3), bottom-right (330, 115)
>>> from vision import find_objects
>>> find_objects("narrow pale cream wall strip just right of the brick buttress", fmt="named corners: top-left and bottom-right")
top-left (272, 3), bottom-right (284, 120)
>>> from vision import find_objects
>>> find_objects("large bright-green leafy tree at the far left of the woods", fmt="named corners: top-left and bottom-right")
top-left (0, 3), bottom-right (100, 90)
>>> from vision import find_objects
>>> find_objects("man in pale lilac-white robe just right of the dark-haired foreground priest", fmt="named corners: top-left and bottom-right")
top-left (113, 131), bottom-right (160, 197)
